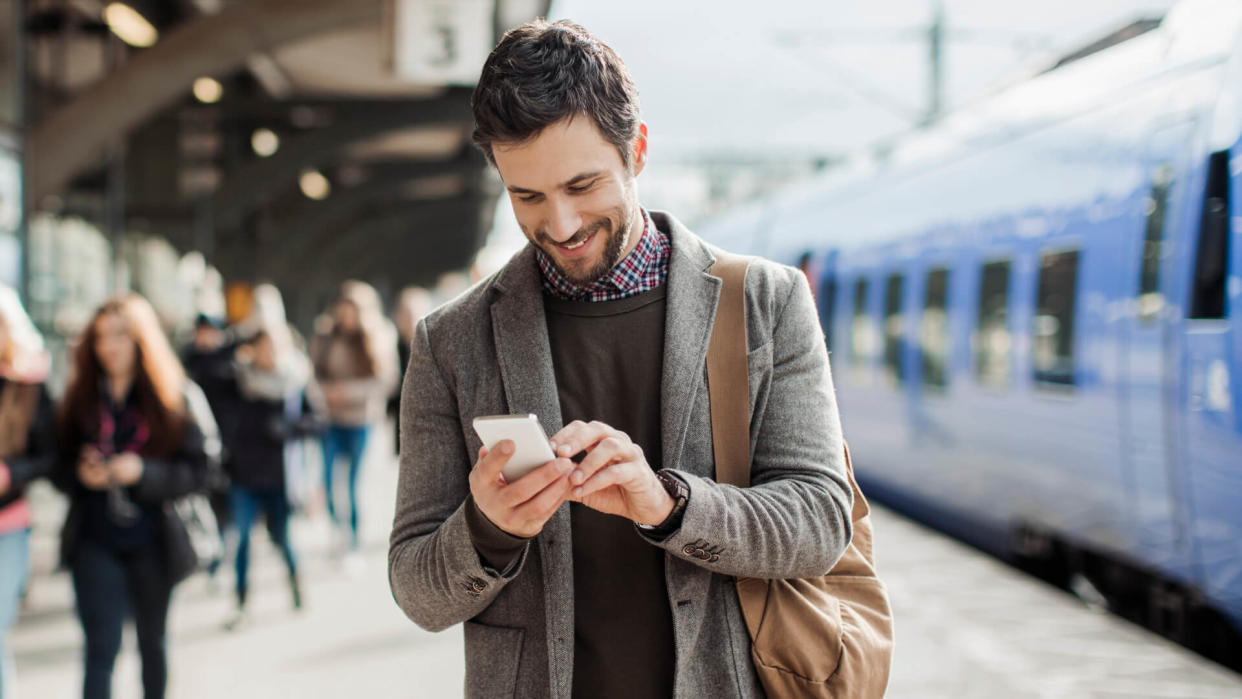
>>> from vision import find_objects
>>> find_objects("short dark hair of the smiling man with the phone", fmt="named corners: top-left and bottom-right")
top-left (471, 19), bottom-right (640, 168)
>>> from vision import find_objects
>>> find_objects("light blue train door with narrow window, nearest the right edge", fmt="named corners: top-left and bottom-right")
top-left (1118, 120), bottom-right (1195, 564)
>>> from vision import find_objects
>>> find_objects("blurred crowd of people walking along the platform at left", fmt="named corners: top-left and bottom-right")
top-left (0, 281), bottom-right (431, 698)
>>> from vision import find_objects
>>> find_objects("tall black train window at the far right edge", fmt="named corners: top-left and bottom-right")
top-left (1190, 150), bottom-right (1230, 319)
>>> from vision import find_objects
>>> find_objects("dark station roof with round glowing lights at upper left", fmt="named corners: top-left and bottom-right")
top-left (25, 0), bottom-right (550, 317)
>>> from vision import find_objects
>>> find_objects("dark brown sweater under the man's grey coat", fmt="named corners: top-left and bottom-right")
top-left (467, 287), bottom-right (674, 699)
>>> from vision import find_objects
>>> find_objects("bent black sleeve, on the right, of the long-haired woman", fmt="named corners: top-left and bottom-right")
top-left (133, 381), bottom-right (220, 503)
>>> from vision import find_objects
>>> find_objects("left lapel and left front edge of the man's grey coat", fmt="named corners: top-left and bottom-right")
top-left (492, 246), bottom-right (574, 697)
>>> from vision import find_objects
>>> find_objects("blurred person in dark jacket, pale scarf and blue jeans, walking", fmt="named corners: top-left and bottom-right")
top-left (218, 329), bottom-right (311, 631)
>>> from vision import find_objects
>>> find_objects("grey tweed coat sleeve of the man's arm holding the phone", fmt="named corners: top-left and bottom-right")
top-left (389, 320), bottom-right (529, 631)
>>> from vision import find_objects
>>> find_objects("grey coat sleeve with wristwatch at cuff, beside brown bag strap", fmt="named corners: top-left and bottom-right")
top-left (640, 268), bottom-right (853, 579)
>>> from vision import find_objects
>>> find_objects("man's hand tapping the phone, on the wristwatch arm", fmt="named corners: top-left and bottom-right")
top-left (551, 420), bottom-right (677, 526)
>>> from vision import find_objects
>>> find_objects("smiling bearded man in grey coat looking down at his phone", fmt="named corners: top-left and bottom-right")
top-left (389, 21), bottom-right (852, 698)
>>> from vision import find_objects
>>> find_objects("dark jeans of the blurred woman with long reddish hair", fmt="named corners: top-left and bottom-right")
top-left (72, 538), bottom-right (173, 699)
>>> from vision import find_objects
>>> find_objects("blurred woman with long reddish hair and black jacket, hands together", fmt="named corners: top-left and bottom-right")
top-left (53, 294), bottom-right (220, 699)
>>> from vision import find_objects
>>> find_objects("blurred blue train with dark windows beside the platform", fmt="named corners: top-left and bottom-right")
top-left (699, 0), bottom-right (1242, 667)
